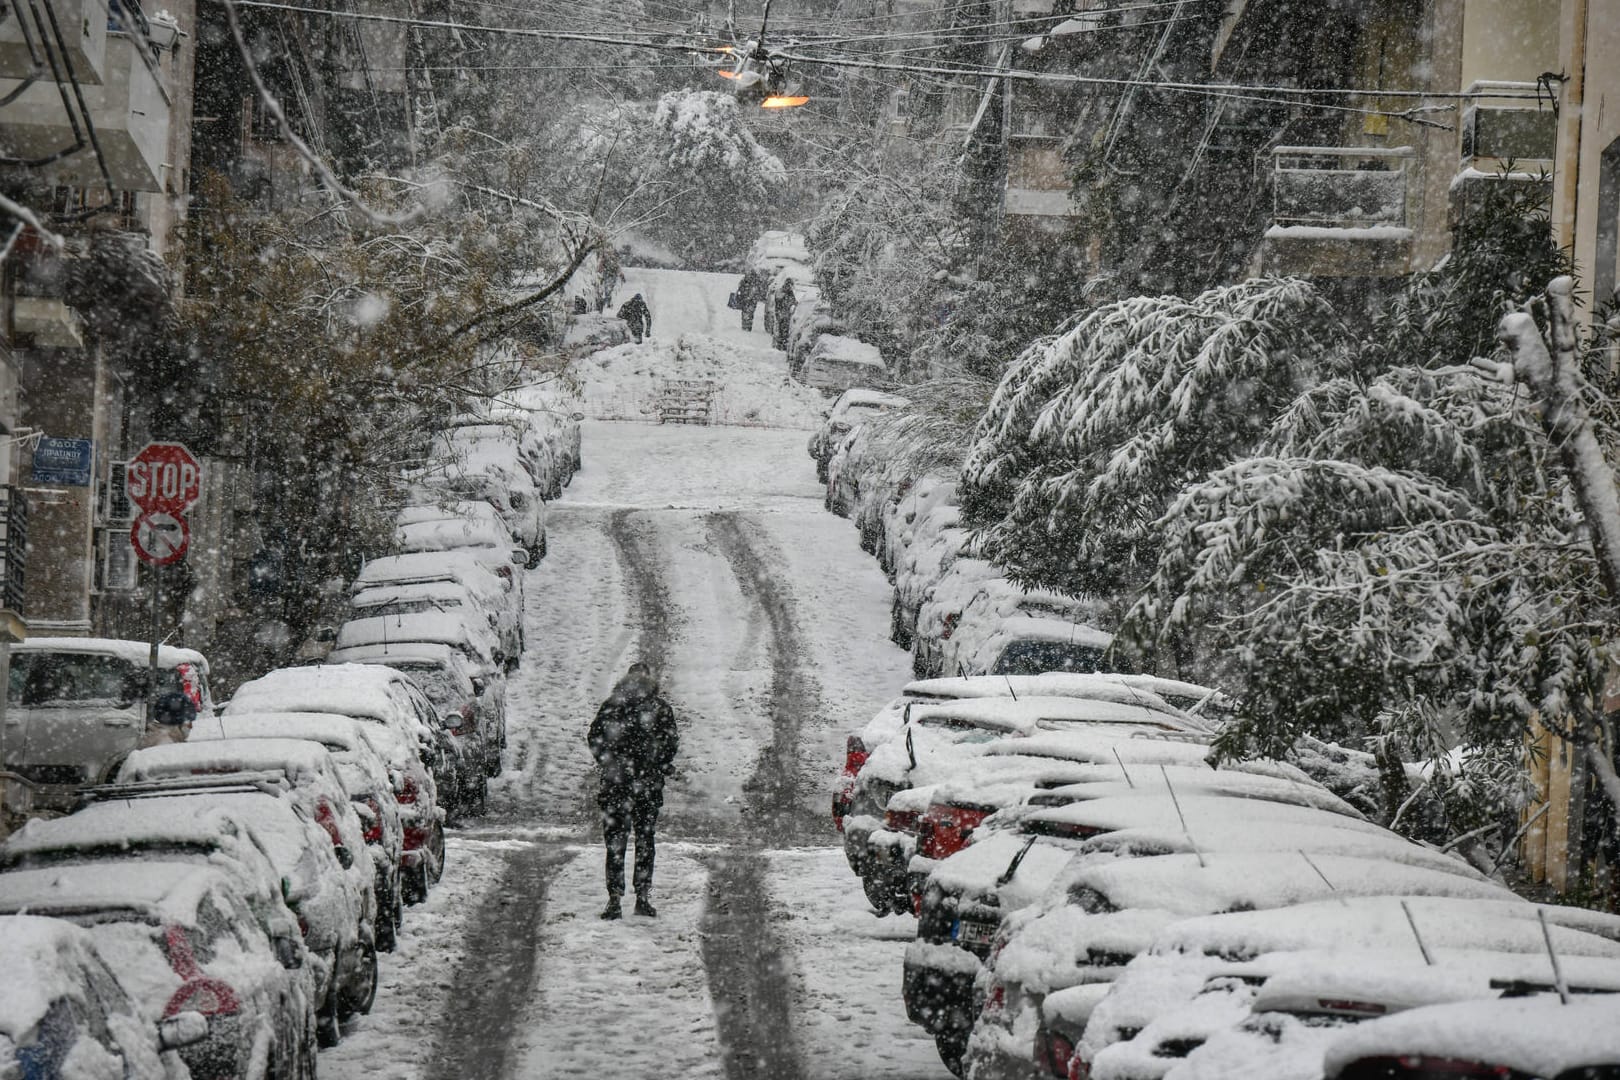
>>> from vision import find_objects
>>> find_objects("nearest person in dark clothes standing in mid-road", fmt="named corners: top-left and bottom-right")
top-left (586, 664), bottom-right (680, 918)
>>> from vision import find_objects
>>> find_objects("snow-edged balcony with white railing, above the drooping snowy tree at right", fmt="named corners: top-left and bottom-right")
top-left (1257, 146), bottom-right (1416, 277)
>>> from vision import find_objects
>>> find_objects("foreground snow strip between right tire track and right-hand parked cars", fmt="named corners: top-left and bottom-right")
top-left (766, 848), bottom-right (951, 1080)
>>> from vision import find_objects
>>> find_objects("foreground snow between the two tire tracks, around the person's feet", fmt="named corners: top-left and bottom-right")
top-left (514, 844), bottom-right (721, 1080)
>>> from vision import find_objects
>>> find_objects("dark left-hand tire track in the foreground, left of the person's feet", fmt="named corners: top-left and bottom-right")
top-left (424, 844), bottom-right (572, 1080)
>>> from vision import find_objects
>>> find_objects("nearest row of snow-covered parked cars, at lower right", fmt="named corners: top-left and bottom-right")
top-left (834, 674), bottom-right (1620, 1080)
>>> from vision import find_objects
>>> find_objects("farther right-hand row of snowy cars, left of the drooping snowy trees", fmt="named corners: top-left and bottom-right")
top-left (808, 389), bottom-right (1113, 689)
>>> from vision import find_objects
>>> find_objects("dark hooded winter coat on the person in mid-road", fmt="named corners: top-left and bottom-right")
top-left (586, 672), bottom-right (680, 806)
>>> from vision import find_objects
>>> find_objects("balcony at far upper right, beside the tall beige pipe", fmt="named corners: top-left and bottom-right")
top-left (1450, 81), bottom-right (1558, 223)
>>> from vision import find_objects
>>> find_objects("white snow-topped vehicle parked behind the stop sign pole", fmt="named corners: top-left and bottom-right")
top-left (0, 636), bottom-right (214, 813)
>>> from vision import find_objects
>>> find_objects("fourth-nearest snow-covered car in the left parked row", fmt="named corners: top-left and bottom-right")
top-left (118, 744), bottom-right (377, 1015)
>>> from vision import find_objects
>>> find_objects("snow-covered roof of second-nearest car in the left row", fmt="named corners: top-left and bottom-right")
top-left (0, 860), bottom-right (232, 926)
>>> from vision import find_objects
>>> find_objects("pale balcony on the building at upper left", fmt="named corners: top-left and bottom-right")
top-left (0, 31), bottom-right (170, 191)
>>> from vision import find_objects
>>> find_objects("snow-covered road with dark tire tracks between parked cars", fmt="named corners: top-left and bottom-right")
top-left (321, 270), bottom-right (948, 1080)
